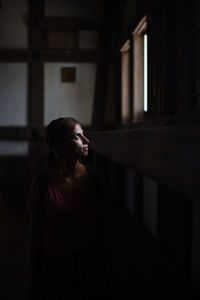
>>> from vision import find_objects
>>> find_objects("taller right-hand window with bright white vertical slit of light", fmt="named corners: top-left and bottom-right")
top-left (133, 16), bottom-right (148, 122)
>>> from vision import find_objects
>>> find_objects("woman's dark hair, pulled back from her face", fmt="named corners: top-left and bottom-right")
top-left (45, 117), bottom-right (79, 168)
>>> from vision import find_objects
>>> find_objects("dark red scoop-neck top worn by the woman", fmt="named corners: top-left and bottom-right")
top-left (28, 176), bottom-right (97, 252)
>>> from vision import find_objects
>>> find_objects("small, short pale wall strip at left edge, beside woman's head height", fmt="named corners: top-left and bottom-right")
top-left (0, 141), bottom-right (28, 156)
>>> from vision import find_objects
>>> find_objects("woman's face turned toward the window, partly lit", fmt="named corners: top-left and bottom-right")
top-left (59, 124), bottom-right (89, 159)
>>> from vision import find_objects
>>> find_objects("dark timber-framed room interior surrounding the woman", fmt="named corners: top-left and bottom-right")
top-left (0, 0), bottom-right (200, 300)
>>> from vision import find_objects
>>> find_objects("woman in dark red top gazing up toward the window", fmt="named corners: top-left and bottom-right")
top-left (28, 117), bottom-right (108, 299)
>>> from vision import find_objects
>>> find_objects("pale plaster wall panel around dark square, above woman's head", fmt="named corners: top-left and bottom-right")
top-left (44, 63), bottom-right (96, 125)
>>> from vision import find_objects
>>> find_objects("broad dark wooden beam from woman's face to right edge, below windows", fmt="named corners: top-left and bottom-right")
top-left (87, 126), bottom-right (200, 200)
